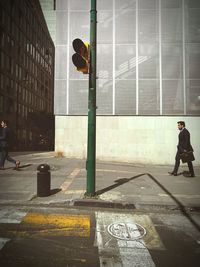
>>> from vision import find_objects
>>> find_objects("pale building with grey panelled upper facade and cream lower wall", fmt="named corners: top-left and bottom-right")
top-left (41, 0), bottom-right (200, 164)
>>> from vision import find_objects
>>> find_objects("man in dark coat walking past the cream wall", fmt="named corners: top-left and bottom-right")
top-left (169, 121), bottom-right (195, 177)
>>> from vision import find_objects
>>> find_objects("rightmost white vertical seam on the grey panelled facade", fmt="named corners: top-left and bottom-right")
top-left (182, 0), bottom-right (186, 115)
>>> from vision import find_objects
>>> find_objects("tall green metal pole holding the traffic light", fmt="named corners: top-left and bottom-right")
top-left (85, 0), bottom-right (97, 197)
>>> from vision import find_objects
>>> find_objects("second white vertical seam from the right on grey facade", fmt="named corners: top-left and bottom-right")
top-left (158, 0), bottom-right (163, 115)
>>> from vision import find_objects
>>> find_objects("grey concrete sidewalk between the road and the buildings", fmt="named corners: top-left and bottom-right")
top-left (0, 152), bottom-right (200, 210)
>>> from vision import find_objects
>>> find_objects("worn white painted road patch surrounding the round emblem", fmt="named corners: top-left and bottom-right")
top-left (95, 212), bottom-right (164, 267)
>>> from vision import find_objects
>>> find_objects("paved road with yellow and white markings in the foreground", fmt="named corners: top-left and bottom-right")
top-left (0, 205), bottom-right (200, 267)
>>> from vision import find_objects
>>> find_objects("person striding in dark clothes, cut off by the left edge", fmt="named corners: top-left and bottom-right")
top-left (0, 120), bottom-right (20, 170)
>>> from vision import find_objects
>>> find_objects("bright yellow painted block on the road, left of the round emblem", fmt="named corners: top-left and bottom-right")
top-left (19, 213), bottom-right (90, 237)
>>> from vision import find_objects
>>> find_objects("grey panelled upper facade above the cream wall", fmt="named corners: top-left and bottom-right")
top-left (54, 0), bottom-right (200, 115)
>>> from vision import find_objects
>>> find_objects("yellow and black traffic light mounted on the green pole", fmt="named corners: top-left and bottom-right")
top-left (72, 38), bottom-right (89, 74)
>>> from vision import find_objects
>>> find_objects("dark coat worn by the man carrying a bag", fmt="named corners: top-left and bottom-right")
top-left (177, 128), bottom-right (193, 153)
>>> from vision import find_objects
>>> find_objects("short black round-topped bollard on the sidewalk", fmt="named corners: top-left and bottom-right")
top-left (37, 164), bottom-right (51, 197)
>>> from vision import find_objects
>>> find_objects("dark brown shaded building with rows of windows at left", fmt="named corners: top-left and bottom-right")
top-left (0, 0), bottom-right (55, 150)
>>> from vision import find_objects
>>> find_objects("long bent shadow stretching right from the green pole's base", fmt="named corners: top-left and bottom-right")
top-left (96, 173), bottom-right (200, 232)
